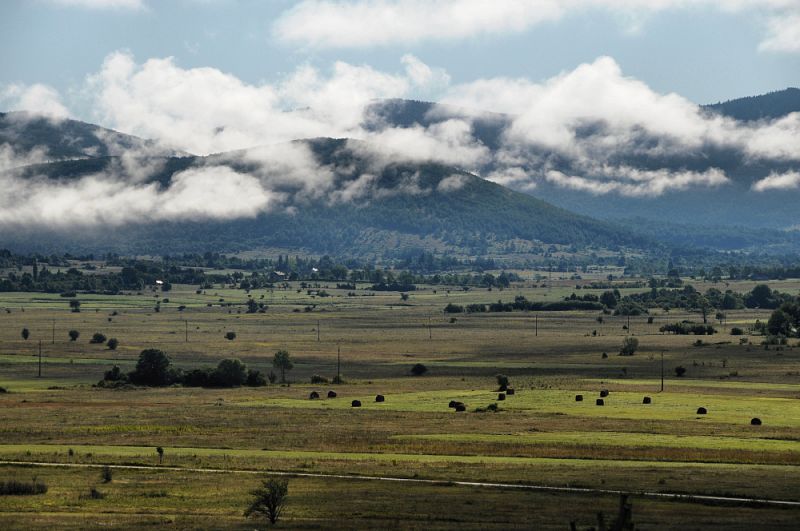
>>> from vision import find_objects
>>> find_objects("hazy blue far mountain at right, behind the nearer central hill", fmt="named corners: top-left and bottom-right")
top-left (365, 94), bottom-right (800, 232)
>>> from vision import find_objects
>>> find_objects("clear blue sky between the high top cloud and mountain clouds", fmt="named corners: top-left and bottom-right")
top-left (0, 0), bottom-right (800, 110)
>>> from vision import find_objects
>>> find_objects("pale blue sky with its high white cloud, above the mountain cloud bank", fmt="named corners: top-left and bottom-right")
top-left (0, 0), bottom-right (800, 110)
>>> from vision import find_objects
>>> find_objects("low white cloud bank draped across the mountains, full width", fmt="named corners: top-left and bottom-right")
top-left (0, 52), bottom-right (800, 229)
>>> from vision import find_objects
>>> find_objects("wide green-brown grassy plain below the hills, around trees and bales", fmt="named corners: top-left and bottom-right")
top-left (0, 279), bottom-right (800, 529)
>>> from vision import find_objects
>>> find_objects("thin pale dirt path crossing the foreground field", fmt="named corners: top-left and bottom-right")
top-left (0, 460), bottom-right (800, 508)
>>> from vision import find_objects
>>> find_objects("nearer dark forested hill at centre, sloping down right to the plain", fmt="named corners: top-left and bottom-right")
top-left (0, 139), bottom-right (653, 256)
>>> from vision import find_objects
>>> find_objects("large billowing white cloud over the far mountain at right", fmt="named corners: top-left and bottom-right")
top-left (444, 57), bottom-right (800, 195)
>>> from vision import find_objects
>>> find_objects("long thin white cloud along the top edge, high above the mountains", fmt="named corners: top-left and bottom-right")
top-left (273, 0), bottom-right (800, 51)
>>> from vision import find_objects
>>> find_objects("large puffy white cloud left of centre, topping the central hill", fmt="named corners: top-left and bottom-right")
top-left (87, 52), bottom-right (411, 154)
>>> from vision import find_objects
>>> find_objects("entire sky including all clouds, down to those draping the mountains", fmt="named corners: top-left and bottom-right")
top-left (0, 0), bottom-right (800, 225)
